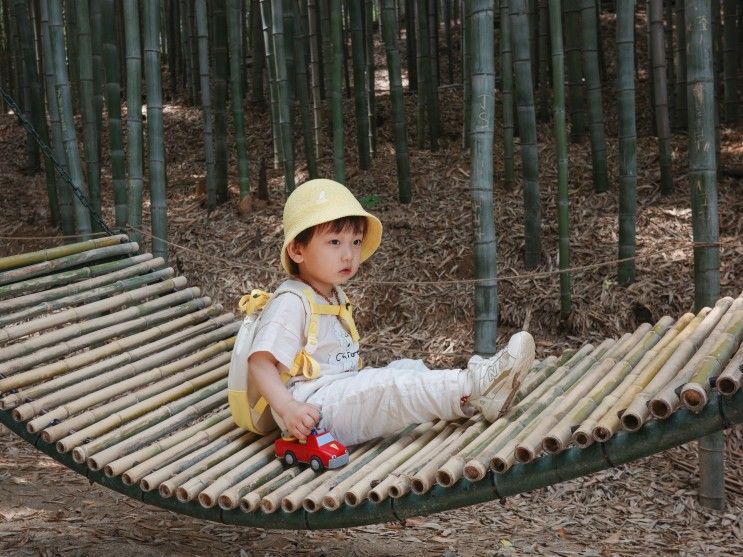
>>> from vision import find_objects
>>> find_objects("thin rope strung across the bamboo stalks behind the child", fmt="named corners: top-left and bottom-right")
top-left (127, 225), bottom-right (733, 286)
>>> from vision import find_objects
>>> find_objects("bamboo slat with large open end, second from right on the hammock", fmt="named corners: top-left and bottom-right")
top-left (680, 298), bottom-right (743, 413)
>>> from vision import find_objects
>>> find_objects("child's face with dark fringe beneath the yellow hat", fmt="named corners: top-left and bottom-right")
top-left (287, 227), bottom-right (364, 295)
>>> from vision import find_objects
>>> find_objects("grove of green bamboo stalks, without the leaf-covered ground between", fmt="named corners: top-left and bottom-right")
top-left (0, 0), bottom-right (743, 510)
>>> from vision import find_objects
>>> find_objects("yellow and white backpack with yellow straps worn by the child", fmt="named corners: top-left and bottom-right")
top-left (227, 281), bottom-right (359, 435)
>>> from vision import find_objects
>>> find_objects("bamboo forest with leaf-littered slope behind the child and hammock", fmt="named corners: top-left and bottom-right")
top-left (0, 0), bottom-right (743, 516)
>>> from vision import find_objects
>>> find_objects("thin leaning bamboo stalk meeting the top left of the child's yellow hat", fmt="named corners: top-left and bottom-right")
top-left (287, 0), bottom-right (320, 178)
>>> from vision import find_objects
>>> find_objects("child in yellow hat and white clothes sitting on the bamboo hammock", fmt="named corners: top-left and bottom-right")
top-left (248, 179), bottom-right (534, 445)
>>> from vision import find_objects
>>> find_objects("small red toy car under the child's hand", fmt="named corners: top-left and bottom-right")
top-left (274, 429), bottom-right (348, 472)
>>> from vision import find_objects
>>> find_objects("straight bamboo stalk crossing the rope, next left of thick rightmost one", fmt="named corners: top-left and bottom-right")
top-left (617, 0), bottom-right (637, 285)
